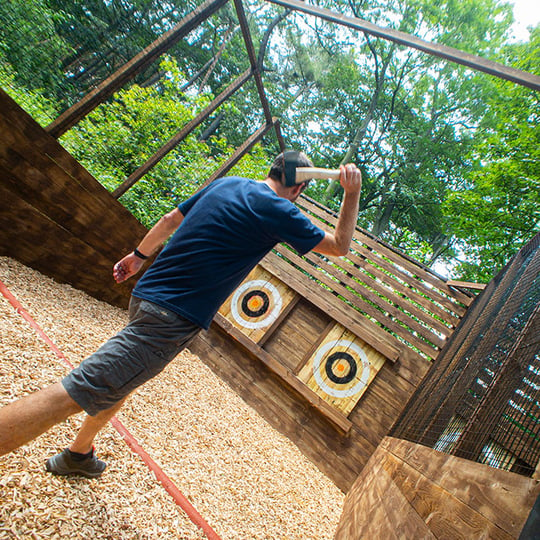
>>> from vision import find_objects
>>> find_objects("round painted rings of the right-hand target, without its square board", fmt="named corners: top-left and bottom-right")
top-left (313, 339), bottom-right (370, 398)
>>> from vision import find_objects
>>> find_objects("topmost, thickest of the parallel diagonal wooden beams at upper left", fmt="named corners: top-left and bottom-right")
top-left (45, 0), bottom-right (228, 138)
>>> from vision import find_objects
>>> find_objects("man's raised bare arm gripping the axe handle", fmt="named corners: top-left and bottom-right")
top-left (313, 163), bottom-right (362, 256)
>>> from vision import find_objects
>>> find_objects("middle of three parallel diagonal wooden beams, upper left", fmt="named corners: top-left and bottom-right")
top-left (112, 69), bottom-right (252, 199)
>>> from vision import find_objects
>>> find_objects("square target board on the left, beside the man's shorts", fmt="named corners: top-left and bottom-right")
top-left (219, 266), bottom-right (296, 342)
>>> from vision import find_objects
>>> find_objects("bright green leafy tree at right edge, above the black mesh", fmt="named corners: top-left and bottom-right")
top-left (444, 27), bottom-right (540, 281)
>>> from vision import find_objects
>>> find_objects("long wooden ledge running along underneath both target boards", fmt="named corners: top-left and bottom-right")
top-left (214, 313), bottom-right (351, 433)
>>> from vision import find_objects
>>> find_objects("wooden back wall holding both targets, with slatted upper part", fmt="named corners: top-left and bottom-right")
top-left (191, 198), bottom-right (473, 492)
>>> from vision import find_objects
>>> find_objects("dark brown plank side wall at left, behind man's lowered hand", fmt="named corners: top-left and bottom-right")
top-left (0, 90), bottom-right (146, 307)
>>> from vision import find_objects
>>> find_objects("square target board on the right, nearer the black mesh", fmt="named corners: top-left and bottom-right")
top-left (298, 324), bottom-right (385, 415)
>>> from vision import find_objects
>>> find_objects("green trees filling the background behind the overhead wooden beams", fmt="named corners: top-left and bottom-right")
top-left (0, 0), bottom-right (540, 281)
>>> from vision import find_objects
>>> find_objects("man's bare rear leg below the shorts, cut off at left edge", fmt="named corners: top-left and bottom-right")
top-left (0, 383), bottom-right (82, 456)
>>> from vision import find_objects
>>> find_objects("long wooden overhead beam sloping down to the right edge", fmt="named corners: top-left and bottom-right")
top-left (267, 0), bottom-right (540, 90)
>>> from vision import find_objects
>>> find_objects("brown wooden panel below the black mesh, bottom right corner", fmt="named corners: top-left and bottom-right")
top-left (335, 437), bottom-right (540, 540)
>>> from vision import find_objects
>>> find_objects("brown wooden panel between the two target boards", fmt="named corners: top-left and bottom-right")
top-left (262, 299), bottom-right (332, 373)
